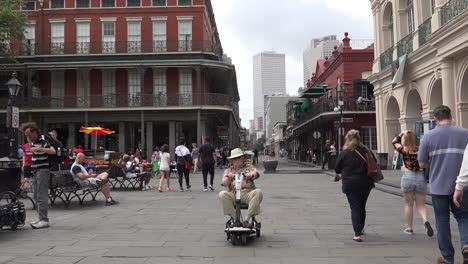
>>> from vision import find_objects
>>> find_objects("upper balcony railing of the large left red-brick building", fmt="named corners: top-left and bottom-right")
top-left (10, 40), bottom-right (222, 57)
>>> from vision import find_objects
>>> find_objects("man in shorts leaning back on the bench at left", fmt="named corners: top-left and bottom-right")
top-left (70, 153), bottom-right (119, 205)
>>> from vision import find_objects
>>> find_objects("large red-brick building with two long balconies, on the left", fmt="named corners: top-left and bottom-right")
top-left (0, 0), bottom-right (240, 158)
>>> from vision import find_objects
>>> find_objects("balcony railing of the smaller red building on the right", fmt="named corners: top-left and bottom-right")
top-left (293, 98), bottom-right (375, 126)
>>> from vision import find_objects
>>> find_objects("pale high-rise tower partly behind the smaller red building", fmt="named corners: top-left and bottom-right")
top-left (302, 35), bottom-right (340, 86)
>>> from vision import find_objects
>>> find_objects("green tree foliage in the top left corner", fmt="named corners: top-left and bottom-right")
top-left (0, 0), bottom-right (28, 60)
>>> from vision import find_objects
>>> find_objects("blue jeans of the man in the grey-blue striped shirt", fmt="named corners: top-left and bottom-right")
top-left (432, 190), bottom-right (468, 263)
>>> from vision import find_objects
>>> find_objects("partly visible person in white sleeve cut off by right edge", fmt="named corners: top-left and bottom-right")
top-left (453, 142), bottom-right (468, 264)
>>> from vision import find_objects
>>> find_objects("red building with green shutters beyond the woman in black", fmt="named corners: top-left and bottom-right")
top-left (288, 33), bottom-right (377, 160)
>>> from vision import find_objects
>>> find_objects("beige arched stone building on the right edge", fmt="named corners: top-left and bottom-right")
top-left (369, 0), bottom-right (468, 165)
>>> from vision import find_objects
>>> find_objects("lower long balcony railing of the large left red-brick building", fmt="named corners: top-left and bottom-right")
top-left (0, 93), bottom-right (237, 111)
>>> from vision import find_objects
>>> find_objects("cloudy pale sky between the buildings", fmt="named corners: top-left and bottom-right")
top-left (211, 0), bottom-right (373, 128)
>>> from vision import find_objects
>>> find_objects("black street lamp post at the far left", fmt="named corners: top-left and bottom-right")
top-left (6, 72), bottom-right (22, 159)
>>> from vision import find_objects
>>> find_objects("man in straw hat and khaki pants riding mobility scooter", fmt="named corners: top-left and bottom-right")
top-left (219, 148), bottom-right (263, 227)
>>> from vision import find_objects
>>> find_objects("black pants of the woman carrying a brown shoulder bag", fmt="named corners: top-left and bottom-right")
top-left (346, 190), bottom-right (371, 236)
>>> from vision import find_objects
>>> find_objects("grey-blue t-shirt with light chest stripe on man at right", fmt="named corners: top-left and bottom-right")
top-left (418, 124), bottom-right (468, 195)
